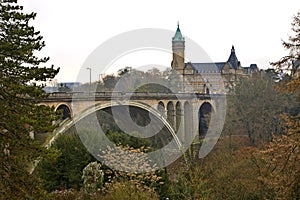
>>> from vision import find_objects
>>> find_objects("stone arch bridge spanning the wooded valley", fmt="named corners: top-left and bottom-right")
top-left (40, 92), bottom-right (224, 145)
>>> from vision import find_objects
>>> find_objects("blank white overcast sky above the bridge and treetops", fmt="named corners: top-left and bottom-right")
top-left (20, 0), bottom-right (300, 82)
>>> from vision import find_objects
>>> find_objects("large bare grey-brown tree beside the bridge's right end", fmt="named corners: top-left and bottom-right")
top-left (223, 77), bottom-right (294, 145)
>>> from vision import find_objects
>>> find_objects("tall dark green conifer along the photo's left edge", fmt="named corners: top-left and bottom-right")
top-left (0, 0), bottom-right (59, 199)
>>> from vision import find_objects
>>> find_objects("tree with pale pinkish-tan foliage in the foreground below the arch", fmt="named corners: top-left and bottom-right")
top-left (98, 145), bottom-right (164, 199)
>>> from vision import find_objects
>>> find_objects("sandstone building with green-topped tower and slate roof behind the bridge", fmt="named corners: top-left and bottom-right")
top-left (171, 24), bottom-right (259, 93)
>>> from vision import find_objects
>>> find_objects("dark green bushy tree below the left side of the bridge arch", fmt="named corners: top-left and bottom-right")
top-left (35, 133), bottom-right (95, 192)
